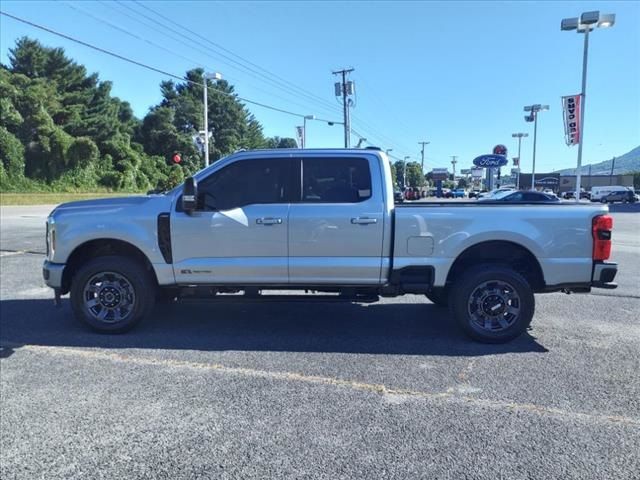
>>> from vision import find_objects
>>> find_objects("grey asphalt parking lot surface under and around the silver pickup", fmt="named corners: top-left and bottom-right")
top-left (0, 201), bottom-right (640, 480)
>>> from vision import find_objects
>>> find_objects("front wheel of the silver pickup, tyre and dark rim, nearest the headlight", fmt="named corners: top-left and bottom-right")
top-left (71, 256), bottom-right (156, 333)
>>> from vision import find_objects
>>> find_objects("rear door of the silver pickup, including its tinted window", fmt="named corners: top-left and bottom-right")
top-left (288, 153), bottom-right (385, 285)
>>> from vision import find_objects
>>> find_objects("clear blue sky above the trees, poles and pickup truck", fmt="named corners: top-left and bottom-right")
top-left (0, 0), bottom-right (640, 172)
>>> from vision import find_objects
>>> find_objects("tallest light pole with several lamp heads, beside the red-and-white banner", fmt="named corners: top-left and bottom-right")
top-left (560, 11), bottom-right (616, 202)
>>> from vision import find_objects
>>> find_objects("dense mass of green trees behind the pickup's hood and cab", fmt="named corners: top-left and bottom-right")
top-left (0, 37), bottom-right (304, 190)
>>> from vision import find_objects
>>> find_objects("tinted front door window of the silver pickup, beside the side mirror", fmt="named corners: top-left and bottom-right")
top-left (198, 158), bottom-right (290, 210)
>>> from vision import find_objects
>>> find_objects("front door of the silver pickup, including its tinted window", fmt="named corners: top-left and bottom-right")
top-left (171, 158), bottom-right (292, 285)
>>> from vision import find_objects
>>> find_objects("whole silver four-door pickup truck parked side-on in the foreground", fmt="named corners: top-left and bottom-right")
top-left (43, 149), bottom-right (617, 343)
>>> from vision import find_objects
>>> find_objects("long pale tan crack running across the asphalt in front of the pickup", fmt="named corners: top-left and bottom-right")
top-left (3, 344), bottom-right (640, 427)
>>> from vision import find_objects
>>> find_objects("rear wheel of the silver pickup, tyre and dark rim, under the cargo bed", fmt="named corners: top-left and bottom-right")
top-left (451, 265), bottom-right (535, 343)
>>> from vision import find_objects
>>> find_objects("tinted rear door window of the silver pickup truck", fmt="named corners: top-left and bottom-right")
top-left (302, 158), bottom-right (371, 203)
